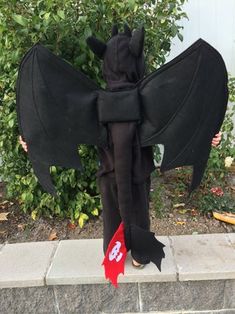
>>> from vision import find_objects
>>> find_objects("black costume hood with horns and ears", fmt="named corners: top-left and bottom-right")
top-left (87, 24), bottom-right (145, 90)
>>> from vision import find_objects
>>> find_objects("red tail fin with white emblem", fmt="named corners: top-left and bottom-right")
top-left (102, 222), bottom-right (127, 288)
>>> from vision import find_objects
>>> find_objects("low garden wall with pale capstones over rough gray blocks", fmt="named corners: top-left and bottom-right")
top-left (0, 233), bottom-right (235, 314)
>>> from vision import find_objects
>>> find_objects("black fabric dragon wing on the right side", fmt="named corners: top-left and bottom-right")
top-left (138, 39), bottom-right (228, 190)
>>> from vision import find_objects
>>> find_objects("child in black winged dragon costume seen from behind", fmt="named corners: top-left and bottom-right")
top-left (17, 25), bottom-right (227, 285)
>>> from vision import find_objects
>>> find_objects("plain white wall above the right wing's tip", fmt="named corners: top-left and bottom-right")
top-left (167, 0), bottom-right (235, 76)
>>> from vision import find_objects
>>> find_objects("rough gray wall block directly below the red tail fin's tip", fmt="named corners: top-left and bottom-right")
top-left (54, 284), bottom-right (139, 314)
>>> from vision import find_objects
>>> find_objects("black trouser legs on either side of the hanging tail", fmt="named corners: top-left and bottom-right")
top-left (98, 174), bottom-right (150, 264)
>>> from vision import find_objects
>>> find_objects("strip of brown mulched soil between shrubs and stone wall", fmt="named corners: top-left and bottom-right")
top-left (0, 172), bottom-right (235, 243)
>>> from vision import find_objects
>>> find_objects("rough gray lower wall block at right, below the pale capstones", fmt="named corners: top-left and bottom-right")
top-left (139, 280), bottom-right (224, 312)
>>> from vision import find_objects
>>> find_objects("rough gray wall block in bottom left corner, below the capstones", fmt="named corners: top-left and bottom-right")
top-left (0, 287), bottom-right (57, 314)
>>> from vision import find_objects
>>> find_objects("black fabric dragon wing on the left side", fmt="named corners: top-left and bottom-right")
top-left (17, 44), bottom-right (104, 194)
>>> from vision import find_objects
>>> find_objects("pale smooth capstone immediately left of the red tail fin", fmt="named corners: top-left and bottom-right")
top-left (46, 239), bottom-right (106, 285)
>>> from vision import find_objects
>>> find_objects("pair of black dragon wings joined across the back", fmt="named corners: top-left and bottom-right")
top-left (17, 39), bottom-right (228, 194)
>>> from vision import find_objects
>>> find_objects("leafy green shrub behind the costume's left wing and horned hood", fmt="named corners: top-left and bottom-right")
top-left (0, 0), bottom-right (186, 222)
